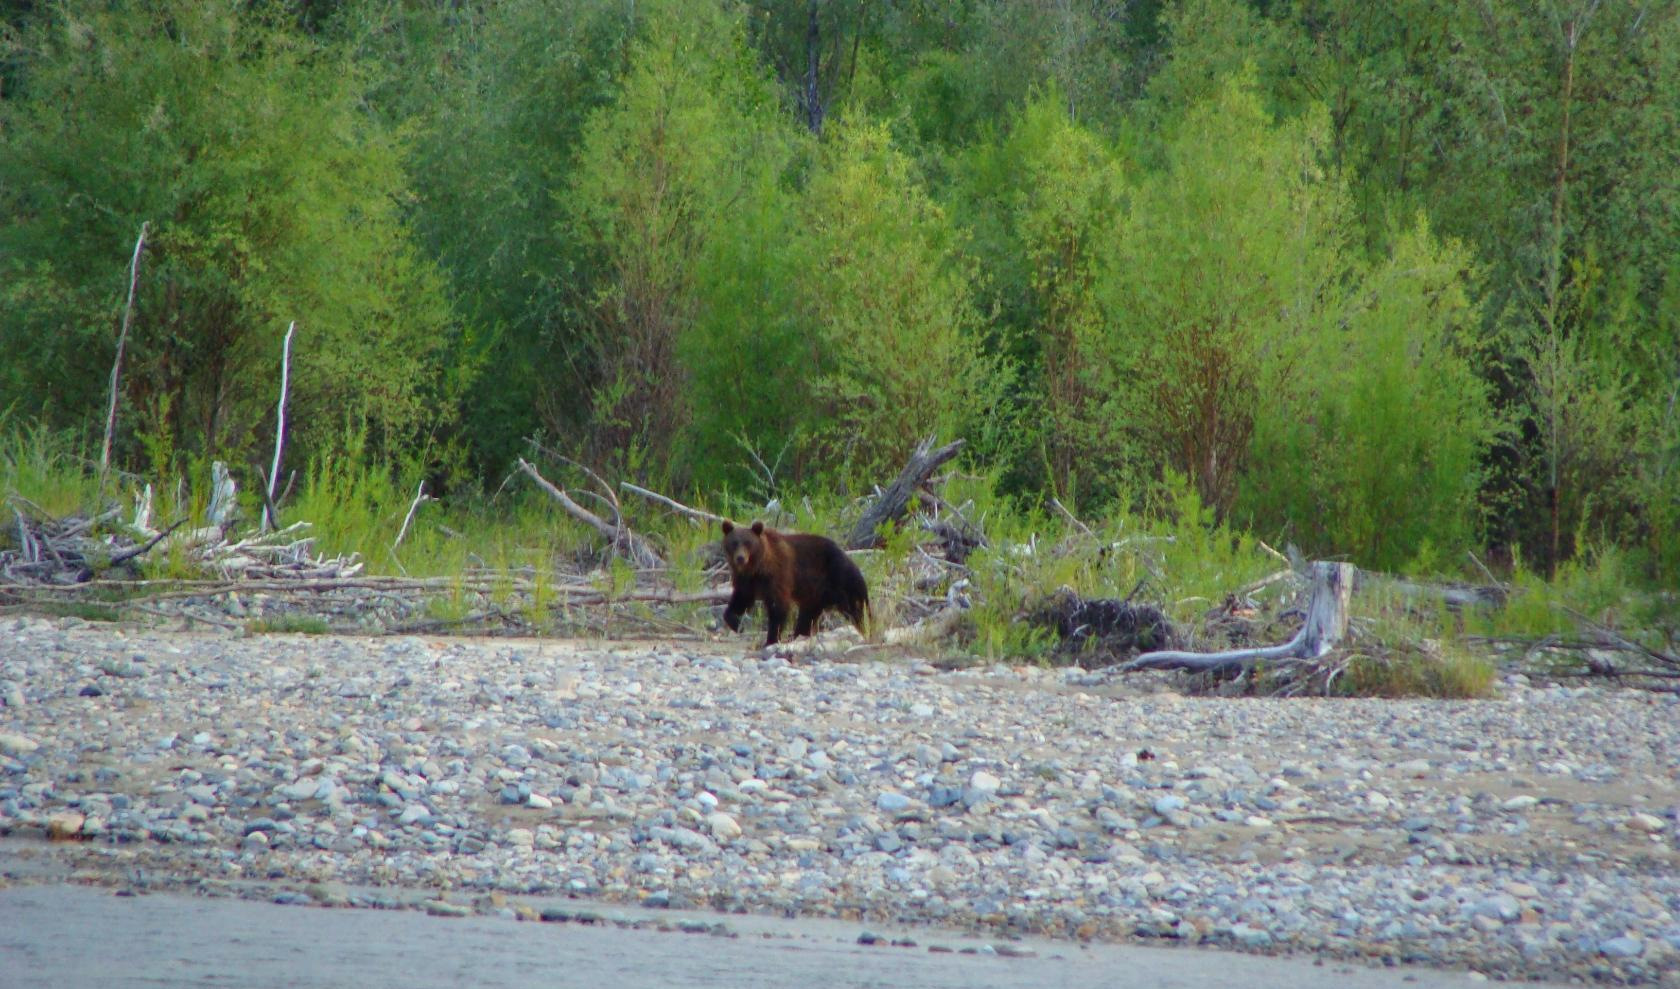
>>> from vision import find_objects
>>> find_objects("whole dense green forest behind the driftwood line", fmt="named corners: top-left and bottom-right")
top-left (0, 0), bottom-right (1680, 586)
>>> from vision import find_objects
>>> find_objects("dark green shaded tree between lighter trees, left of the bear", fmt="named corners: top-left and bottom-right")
top-left (389, 0), bottom-right (637, 474)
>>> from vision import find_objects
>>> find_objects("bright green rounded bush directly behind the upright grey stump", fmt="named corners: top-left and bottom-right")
top-left (1240, 223), bottom-right (1495, 569)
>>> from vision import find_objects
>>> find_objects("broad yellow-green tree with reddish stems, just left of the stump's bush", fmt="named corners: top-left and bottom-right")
top-left (1094, 77), bottom-right (1351, 512)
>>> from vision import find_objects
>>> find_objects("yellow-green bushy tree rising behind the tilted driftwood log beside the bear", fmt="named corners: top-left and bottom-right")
top-left (796, 121), bottom-right (1003, 482)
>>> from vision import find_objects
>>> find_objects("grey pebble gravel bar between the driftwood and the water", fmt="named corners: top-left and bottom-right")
top-left (0, 618), bottom-right (1680, 984)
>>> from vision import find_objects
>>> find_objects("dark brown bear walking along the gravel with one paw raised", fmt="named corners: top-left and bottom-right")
top-left (724, 519), bottom-right (870, 646)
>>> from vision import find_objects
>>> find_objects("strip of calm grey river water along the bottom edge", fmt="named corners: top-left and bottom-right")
top-left (0, 885), bottom-right (1539, 989)
